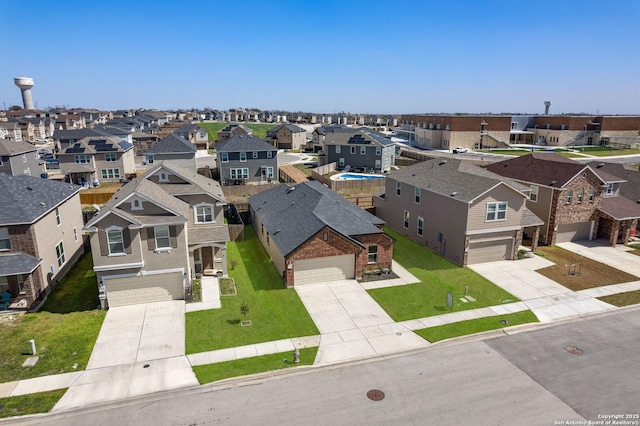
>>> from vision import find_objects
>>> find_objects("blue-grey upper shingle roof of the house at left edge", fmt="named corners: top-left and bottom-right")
top-left (0, 173), bottom-right (80, 225)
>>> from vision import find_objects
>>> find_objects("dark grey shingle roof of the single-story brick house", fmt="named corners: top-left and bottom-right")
top-left (249, 181), bottom-right (384, 256)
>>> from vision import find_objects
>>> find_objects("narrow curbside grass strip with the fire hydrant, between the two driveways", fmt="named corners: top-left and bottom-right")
top-left (193, 347), bottom-right (318, 385)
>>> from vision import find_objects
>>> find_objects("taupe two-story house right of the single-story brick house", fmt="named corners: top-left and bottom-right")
top-left (374, 159), bottom-right (542, 266)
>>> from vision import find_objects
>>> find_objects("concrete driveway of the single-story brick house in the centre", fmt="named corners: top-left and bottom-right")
top-left (295, 280), bottom-right (429, 365)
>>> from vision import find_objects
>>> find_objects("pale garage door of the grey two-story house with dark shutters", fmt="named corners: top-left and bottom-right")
top-left (104, 272), bottom-right (184, 308)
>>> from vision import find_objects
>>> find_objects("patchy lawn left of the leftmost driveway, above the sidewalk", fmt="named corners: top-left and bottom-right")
top-left (0, 310), bottom-right (106, 383)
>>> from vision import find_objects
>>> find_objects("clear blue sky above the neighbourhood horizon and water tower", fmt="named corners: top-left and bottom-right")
top-left (0, 0), bottom-right (640, 114)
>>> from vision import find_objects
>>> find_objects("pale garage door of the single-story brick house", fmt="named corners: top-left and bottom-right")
top-left (293, 254), bottom-right (355, 285)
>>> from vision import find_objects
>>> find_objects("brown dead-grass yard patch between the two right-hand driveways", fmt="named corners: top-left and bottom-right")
top-left (536, 246), bottom-right (638, 291)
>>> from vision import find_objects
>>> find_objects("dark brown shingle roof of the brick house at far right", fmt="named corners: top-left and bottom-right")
top-left (484, 152), bottom-right (616, 188)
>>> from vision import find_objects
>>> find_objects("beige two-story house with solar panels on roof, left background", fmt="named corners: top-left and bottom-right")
top-left (58, 137), bottom-right (136, 185)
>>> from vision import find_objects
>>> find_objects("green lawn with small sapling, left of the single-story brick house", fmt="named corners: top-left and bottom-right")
top-left (186, 226), bottom-right (319, 354)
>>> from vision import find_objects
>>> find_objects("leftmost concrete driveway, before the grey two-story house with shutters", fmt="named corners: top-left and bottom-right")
top-left (54, 301), bottom-right (198, 411)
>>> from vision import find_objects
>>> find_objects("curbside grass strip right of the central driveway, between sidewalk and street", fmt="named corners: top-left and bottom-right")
top-left (415, 311), bottom-right (538, 343)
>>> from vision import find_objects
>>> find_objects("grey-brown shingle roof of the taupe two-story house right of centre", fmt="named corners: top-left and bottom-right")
top-left (388, 158), bottom-right (530, 203)
